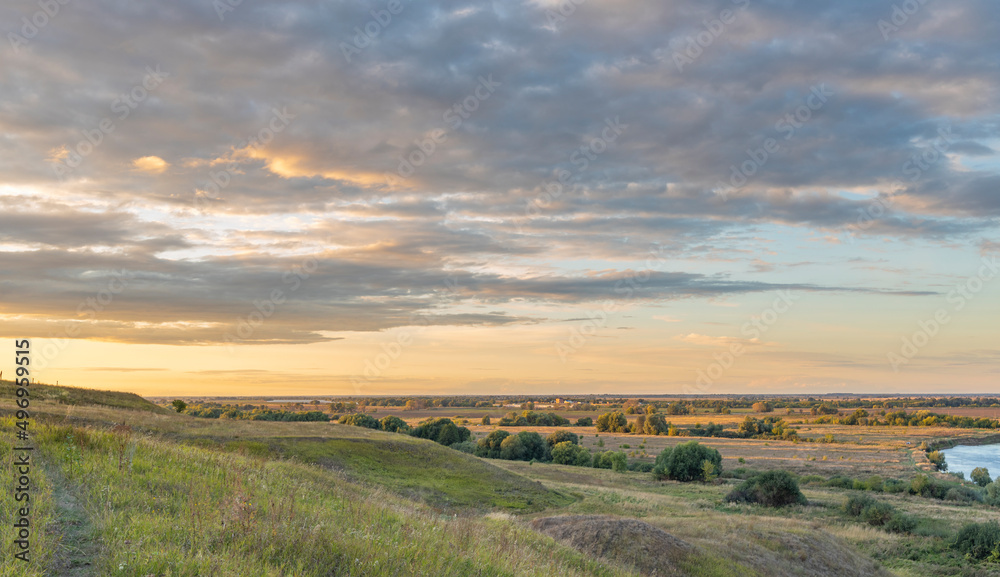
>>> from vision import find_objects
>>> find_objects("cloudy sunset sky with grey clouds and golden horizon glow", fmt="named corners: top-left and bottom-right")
top-left (0, 0), bottom-right (1000, 396)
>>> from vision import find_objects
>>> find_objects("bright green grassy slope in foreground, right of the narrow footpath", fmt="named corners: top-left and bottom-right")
top-left (31, 418), bottom-right (634, 577)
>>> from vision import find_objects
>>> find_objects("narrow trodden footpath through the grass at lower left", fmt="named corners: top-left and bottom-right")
top-left (45, 461), bottom-right (100, 577)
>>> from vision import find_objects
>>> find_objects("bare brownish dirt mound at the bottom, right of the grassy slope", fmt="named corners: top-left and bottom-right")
top-left (531, 515), bottom-right (694, 576)
